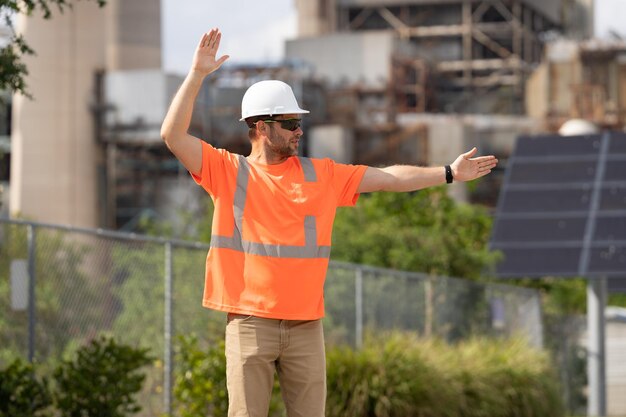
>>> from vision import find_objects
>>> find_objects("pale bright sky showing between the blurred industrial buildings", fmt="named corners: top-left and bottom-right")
top-left (161, 0), bottom-right (626, 74)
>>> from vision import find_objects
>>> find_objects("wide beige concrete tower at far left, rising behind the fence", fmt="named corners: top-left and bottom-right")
top-left (10, 2), bottom-right (106, 226)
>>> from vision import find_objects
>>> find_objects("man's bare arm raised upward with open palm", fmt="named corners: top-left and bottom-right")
top-left (161, 29), bottom-right (228, 174)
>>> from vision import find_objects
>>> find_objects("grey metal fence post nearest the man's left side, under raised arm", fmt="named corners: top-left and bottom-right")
top-left (163, 241), bottom-right (174, 416)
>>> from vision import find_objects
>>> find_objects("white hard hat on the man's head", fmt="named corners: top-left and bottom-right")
top-left (239, 80), bottom-right (309, 121)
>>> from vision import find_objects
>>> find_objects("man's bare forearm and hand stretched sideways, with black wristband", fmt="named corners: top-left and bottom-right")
top-left (357, 148), bottom-right (498, 193)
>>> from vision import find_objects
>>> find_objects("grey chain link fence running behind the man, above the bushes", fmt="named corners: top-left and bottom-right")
top-left (0, 219), bottom-right (543, 416)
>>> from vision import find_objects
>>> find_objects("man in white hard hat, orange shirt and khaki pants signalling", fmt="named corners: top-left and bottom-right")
top-left (161, 29), bottom-right (497, 417)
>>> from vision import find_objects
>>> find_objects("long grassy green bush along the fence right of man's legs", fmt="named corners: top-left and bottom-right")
top-left (327, 334), bottom-right (564, 417)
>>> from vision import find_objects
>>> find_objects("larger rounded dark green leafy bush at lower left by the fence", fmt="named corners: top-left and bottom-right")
top-left (54, 337), bottom-right (152, 417)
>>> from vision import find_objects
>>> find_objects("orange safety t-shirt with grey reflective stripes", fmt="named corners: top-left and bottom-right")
top-left (193, 142), bottom-right (367, 320)
